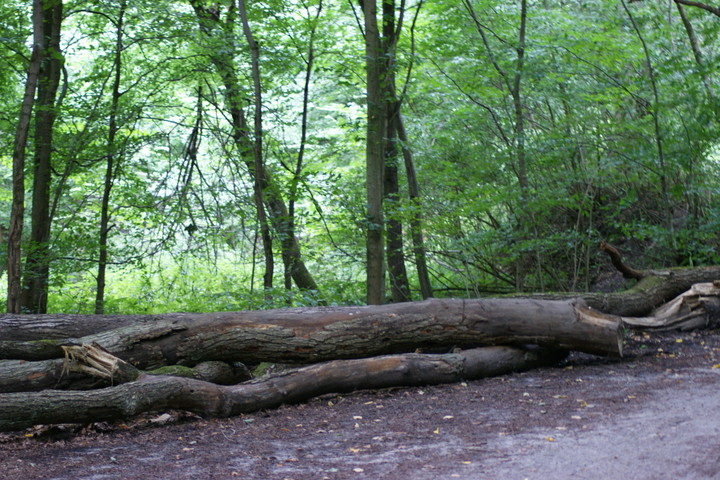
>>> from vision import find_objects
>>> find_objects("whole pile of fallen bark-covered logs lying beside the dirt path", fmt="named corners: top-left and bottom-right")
top-left (0, 262), bottom-right (720, 431)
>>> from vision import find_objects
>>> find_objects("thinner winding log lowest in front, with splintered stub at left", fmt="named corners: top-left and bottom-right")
top-left (0, 346), bottom-right (566, 431)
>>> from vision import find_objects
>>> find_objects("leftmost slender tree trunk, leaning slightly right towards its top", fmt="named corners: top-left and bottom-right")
top-left (7, 0), bottom-right (44, 313)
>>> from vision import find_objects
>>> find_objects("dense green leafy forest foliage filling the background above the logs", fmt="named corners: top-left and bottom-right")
top-left (0, 0), bottom-right (720, 313)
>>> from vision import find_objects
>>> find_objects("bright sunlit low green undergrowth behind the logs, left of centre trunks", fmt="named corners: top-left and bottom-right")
top-left (43, 258), bottom-right (365, 314)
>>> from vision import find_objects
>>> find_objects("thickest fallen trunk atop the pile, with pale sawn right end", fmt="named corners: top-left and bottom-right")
top-left (0, 299), bottom-right (622, 370)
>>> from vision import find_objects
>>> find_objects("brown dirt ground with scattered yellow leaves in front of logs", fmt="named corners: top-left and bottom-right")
top-left (0, 331), bottom-right (720, 480)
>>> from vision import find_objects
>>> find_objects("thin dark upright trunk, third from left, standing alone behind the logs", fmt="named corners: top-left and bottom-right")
top-left (95, 0), bottom-right (127, 314)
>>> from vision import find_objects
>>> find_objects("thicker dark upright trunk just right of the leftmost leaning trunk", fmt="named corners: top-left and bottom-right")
top-left (21, 0), bottom-right (63, 313)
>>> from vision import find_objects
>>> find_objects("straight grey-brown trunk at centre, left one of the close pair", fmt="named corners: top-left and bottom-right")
top-left (363, 0), bottom-right (386, 305)
